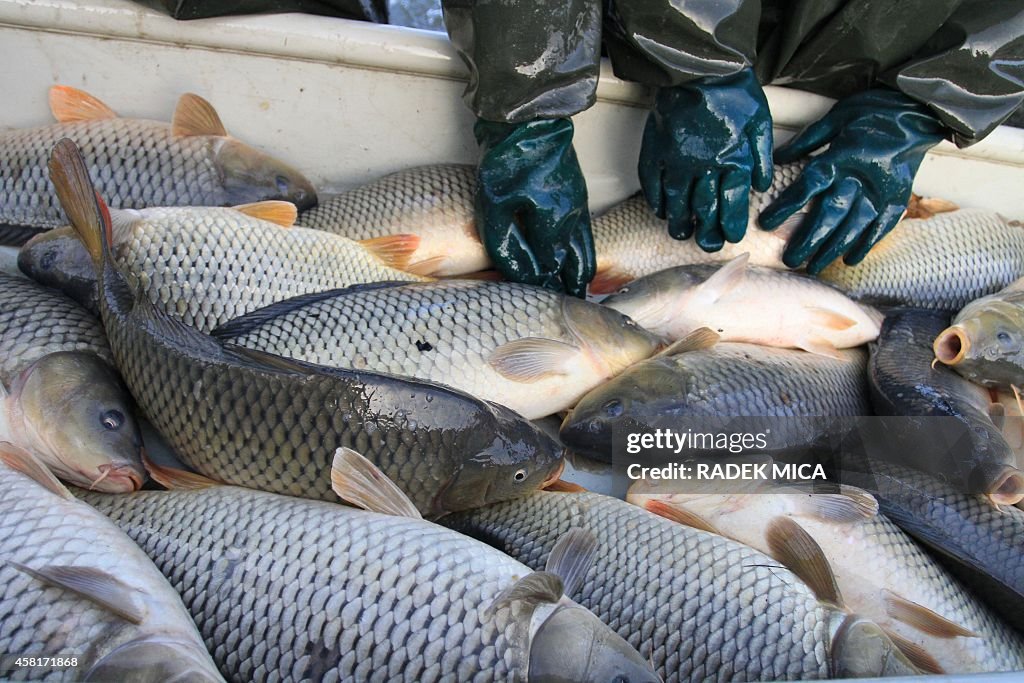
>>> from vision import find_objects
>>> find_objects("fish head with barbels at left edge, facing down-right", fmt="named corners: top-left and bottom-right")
top-left (11, 351), bottom-right (145, 493)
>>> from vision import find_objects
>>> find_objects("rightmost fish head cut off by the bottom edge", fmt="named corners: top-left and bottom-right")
top-left (831, 612), bottom-right (925, 678)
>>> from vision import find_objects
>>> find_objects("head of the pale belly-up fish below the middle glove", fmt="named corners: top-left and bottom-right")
top-left (601, 267), bottom-right (707, 338)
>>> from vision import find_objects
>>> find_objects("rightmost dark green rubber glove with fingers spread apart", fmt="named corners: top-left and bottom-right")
top-left (760, 89), bottom-right (946, 274)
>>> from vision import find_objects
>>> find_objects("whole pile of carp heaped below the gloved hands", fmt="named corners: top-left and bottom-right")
top-left (0, 86), bottom-right (1024, 683)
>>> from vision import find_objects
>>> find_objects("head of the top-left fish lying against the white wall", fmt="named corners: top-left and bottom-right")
top-left (214, 137), bottom-right (316, 211)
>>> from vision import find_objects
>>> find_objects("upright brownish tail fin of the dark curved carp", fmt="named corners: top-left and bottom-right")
top-left (49, 137), bottom-right (113, 267)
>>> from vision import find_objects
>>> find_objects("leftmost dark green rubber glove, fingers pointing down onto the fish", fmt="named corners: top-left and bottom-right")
top-left (473, 119), bottom-right (596, 297)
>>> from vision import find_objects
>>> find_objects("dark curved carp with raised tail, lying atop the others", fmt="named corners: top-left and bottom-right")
top-left (51, 137), bottom-right (561, 515)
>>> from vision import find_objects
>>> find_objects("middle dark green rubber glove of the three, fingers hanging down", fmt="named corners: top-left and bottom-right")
top-left (639, 69), bottom-right (772, 251)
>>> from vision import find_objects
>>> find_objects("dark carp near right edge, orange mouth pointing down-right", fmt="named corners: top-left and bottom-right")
top-left (868, 308), bottom-right (1024, 505)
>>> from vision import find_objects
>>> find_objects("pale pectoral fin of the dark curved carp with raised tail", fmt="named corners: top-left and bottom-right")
top-left (331, 447), bottom-right (423, 519)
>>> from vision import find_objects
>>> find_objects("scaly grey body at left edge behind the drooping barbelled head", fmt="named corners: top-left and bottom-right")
top-left (0, 273), bottom-right (114, 385)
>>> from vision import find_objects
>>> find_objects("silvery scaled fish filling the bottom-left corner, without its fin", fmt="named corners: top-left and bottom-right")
top-left (0, 447), bottom-right (223, 681)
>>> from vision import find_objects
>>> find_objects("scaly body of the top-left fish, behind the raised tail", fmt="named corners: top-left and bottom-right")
top-left (0, 119), bottom-right (218, 229)
